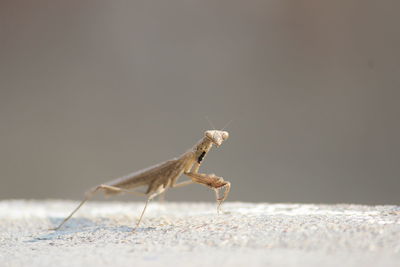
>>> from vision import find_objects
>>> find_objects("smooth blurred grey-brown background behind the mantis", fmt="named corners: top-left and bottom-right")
top-left (0, 0), bottom-right (400, 204)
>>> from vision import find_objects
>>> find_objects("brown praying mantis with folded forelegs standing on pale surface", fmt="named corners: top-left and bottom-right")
top-left (54, 130), bottom-right (231, 230)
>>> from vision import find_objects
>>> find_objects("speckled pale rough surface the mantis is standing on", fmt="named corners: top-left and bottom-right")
top-left (0, 200), bottom-right (400, 267)
